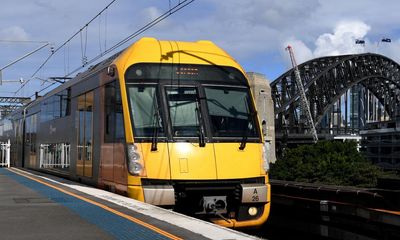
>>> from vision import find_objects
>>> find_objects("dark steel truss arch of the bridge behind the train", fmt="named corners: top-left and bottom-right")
top-left (271, 53), bottom-right (400, 139)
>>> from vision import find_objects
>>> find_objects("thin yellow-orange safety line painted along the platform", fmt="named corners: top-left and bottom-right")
top-left (8, 169), bottom-right (182, 240)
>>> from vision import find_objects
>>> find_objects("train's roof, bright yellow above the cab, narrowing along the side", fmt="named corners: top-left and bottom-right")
top-left (4, 37), bottom-right (245, 117)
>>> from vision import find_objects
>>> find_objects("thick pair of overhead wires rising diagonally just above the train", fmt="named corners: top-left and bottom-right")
top-left (30, 0), bottom-right (195, 97)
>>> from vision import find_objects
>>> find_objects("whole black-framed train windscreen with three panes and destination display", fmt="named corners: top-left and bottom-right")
top-left (125, 63), bottom-right (261, 144)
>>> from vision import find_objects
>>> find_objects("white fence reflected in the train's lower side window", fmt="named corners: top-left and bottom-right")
top-left (40, 143), bottom-right (70, 168)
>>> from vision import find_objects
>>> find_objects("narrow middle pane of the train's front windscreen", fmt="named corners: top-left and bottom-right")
top-left (167, 87), bottom-right (199, 137)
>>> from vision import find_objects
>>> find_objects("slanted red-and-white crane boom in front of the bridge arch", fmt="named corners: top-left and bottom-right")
top-left (286, 46), bottom-right (318, 143)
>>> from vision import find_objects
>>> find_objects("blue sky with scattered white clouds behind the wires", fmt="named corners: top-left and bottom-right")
top-left (0, 0), bottom-right (400, 96)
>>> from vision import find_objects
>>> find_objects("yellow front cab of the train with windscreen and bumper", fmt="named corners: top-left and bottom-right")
top-left (114, 39), bottom-right (270, 227)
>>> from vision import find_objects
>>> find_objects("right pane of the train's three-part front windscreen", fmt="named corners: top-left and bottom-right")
top-left (205, 87), bottom-right (258, 137)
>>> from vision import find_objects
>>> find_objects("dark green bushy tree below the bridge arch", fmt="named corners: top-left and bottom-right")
top-left (270, 141), bottom-right (382, 187)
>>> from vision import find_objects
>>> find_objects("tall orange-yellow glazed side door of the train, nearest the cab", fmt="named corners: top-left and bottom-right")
top-left (76, 91), bottom-right (93, 177)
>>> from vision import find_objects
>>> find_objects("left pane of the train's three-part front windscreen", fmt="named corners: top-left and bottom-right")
top-left (129, 85), bottom-right (164, 137)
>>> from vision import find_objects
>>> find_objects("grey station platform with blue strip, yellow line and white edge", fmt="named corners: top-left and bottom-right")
top-left (0, 168), bottom-right (255, 240)
